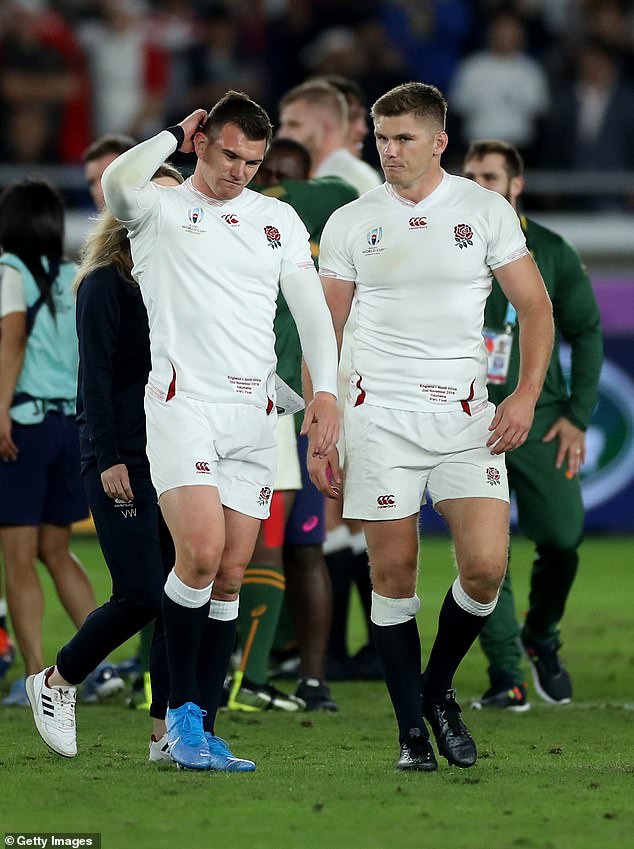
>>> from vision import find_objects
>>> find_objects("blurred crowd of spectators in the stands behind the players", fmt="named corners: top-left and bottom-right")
top-left (0, 0), bottom-right (634, 206)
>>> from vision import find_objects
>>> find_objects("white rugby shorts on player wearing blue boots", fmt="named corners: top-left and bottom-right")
top-left (145, 392), bottom-right (278, 519)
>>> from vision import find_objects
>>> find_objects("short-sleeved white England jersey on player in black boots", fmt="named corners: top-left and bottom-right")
top-left (319, 172), bottom-right (528, 412)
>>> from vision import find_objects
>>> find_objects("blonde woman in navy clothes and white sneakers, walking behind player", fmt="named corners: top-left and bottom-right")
top-left (26, 164), bottom-right (183, 761)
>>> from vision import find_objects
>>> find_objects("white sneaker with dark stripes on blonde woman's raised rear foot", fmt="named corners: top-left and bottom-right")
top-left (26, 667), bottom-right (77, 758)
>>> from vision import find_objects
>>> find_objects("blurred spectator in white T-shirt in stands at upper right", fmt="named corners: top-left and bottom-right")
top-left (450, 11), bottom-right (549, 163)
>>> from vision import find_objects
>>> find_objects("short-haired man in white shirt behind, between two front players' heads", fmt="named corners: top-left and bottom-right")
top-left (277, 79), bottom-right (381, 195)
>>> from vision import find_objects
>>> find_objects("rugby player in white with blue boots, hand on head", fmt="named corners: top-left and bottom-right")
top-left (102, 92), bottom-right (339, 771)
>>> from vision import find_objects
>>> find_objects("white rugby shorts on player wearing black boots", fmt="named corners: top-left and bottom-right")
top-left (343, 402), bottom-right (509, 520)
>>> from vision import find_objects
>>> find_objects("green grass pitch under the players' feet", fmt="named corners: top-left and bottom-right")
top-left (0, 538), bottom-right (634, 849)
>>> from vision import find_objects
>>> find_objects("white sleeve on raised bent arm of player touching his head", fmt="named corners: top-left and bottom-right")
top-left (101, 130), bottom-right (176, 224)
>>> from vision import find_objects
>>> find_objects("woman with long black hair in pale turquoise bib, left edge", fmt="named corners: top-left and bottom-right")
top-left (0, 180), bottom-right (96, 705)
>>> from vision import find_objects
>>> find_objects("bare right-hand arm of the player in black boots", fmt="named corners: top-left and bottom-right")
top-left (487, 254), bottom-right (554, 454)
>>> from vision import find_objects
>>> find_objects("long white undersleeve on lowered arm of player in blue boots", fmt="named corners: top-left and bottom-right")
top-left (280, 267), bottom-right (338, 397)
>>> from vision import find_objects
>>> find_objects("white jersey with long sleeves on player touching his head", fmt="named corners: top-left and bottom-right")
top-left (103, 131), bottom-right (336, 408)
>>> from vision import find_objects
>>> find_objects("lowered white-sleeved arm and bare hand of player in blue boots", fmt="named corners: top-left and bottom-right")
top-left (280, 268), bottom-right (339, 456)
